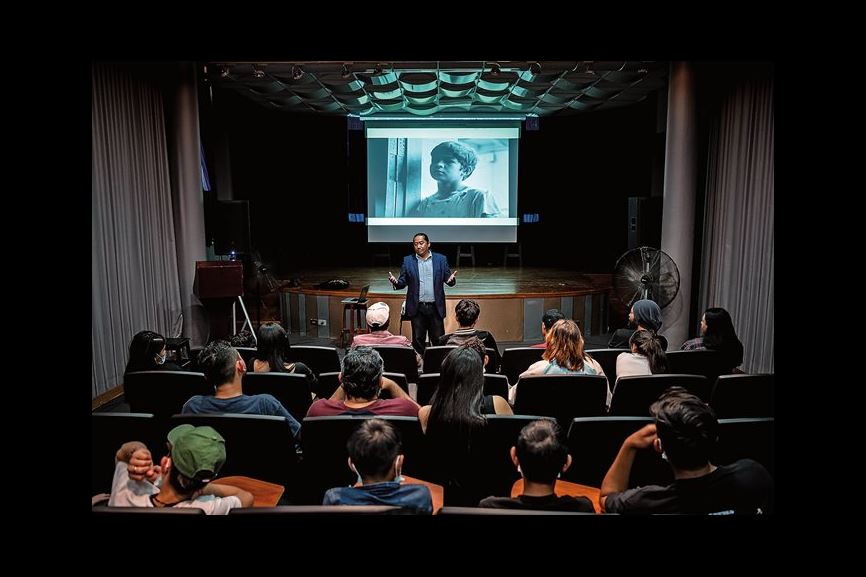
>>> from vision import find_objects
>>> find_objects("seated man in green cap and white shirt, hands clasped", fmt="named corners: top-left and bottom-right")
top-left (108, 424), bottom-right (253, 515)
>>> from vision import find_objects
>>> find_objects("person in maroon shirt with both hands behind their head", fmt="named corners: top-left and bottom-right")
top-left (307, 347), bottom-right (419, 417)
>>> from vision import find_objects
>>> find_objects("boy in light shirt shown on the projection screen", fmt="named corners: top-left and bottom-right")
top-left (411, 141), bottom-right (500, 218)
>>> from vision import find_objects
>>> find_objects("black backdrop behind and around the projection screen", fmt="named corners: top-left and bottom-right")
top-left (202, 85), bottom-right (663, 278)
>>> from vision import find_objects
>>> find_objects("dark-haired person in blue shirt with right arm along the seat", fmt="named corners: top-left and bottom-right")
top-left (181, 341), bottom-right (301, 439)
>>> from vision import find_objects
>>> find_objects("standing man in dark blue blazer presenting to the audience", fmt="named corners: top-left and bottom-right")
top-left (388, 232), bottom-right (457, 355)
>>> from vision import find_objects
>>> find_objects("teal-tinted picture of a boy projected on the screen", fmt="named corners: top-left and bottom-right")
top-left (370, 138), bottom-right (509, 218)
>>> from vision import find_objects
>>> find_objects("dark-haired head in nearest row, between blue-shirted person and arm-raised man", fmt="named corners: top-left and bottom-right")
top-left (517, 419), bottom-right (568, 484)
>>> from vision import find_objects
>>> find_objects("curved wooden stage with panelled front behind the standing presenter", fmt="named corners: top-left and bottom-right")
top-left (280, 267), bottom-right (611, 345)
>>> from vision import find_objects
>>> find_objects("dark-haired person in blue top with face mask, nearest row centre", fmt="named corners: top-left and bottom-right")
top-left (322, 419), bottom-right (433, 515)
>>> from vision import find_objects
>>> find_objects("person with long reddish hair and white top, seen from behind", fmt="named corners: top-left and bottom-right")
top-left (508, 319), bottom-right (611, 407)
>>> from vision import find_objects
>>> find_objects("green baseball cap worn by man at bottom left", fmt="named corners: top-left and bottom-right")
top-left (168, 424), bottom-right (226, 482)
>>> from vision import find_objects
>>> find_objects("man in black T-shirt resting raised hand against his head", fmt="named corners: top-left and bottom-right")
top-left (599, 387), bottom-right (773, 515)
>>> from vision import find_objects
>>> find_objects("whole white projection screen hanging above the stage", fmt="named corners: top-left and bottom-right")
top-left (366, 121), bottom-right (520, 242)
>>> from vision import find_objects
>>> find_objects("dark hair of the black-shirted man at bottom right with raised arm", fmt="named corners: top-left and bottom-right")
top-left (650, 387), bottom-right (719, 470)
